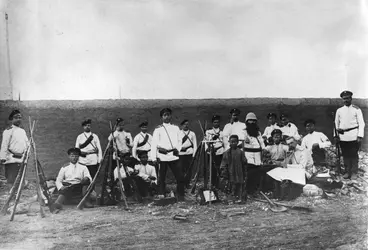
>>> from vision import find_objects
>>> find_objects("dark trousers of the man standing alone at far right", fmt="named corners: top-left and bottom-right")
top-left (340, 141), bottom-right (360, 177)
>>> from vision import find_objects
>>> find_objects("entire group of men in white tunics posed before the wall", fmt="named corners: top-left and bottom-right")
top-left (0, 91), bottom-right (365, 206)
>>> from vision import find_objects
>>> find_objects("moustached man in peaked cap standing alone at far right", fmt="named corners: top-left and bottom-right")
top-left (334, 91), bottom-right (365, 178)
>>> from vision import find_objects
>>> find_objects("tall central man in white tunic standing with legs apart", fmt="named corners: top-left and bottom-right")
top-left (151, 108), bottom-right (184, 201)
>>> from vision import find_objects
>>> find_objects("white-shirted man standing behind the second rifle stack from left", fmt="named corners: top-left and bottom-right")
top-left (108, 118), bottom-right (133, 159)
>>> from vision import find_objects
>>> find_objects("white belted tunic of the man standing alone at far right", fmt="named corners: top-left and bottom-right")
top-left (335, 105), bottom-right (365, 141)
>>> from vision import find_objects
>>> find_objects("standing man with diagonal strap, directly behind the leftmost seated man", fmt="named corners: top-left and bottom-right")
top-left (75, 119), bottom-right (102, 178)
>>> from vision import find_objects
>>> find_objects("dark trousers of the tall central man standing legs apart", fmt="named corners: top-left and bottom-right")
top-left (159, 160), bottom-right (185, 196)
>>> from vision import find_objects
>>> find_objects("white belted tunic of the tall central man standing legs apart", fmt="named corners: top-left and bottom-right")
top-left (151, 123), bottom-right (181, 161)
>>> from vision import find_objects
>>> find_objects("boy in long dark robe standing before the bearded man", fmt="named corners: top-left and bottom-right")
top-left (220, 135), bottom-right (247, 203)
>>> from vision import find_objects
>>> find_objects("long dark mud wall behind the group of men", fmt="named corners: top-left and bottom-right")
top-left (0, 98), bottom-right (368, 178)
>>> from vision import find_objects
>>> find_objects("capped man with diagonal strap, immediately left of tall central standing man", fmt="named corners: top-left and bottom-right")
top-left (132, 121), bottom-right (152, 161)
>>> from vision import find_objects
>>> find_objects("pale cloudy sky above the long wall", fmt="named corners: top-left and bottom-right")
top-left (0, 0), bottom-right (368, 100)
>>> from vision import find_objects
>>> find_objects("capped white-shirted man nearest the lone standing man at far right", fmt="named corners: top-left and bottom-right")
top-left (301, 119), bottom-right (331, 165)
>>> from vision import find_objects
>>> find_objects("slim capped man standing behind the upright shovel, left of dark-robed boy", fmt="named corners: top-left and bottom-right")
top-left (206, 115), bottom-right (224, 187)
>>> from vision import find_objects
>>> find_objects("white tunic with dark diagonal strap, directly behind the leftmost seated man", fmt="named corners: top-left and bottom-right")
top-left (75, 132), bottom-right (102, 166)
